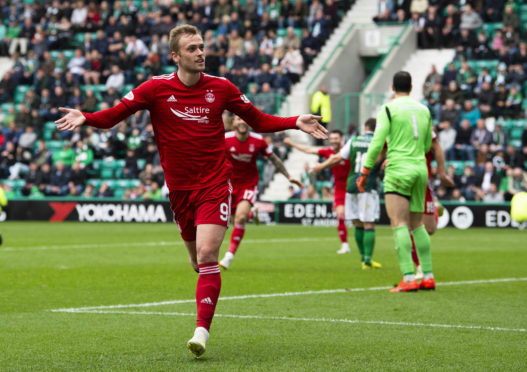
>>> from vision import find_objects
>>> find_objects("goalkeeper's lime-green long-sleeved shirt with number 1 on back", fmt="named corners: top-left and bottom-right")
top-left (364, 96), bottom-right (432, 169)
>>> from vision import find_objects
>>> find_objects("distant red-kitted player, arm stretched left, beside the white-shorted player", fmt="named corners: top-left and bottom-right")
top-left (284, 130), bottom-right (350, 254)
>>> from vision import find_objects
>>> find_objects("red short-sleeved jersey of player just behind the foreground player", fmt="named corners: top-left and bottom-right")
top-left (225, 131), bottom-right (273, 188)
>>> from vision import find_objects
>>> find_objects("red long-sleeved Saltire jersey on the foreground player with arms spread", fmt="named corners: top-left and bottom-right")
top-left (83, 73), bottom-right (297, 190)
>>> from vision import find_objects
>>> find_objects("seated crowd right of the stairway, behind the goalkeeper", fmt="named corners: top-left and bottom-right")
top-left (374, 0), bottom-right (527, 202)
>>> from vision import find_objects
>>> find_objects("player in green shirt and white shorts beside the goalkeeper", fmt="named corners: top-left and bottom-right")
top-left (313, 118), bottom-right (382, 270)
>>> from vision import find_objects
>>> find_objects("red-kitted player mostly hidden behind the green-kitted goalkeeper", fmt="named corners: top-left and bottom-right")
top-left (410, 132), bottom-right (454, 289)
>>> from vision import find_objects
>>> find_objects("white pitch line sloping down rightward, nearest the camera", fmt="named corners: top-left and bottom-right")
top-left (57, 310), bottom-right (527, 332)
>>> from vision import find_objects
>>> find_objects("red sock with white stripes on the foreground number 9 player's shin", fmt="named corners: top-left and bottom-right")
top-left (196, 262), bottom-right (221, 330)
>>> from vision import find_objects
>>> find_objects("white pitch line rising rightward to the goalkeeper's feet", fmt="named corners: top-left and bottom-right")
top-left (49, 278), bottom-right (527, 313)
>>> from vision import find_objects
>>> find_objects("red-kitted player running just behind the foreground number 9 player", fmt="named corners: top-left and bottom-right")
top-left (220, 116), bottom-right (303, 269)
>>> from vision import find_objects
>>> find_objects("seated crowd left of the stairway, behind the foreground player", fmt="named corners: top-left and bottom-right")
top-left (0, 0), bottom-right (351, 199)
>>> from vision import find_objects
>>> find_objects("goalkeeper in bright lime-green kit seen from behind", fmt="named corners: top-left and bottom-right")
top-left (357, 71), bottom-right (435, 292)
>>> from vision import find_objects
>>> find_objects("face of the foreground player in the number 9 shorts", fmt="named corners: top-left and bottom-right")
top-left (172, 35), bottom-right (205, 73)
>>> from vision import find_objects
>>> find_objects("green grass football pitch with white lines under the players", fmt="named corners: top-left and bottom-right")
top-left (0, 222), bottom-right (527, 371)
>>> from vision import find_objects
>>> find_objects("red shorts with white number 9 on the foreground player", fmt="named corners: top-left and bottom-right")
top-left (169, 181), bottom-right (232, 242)
